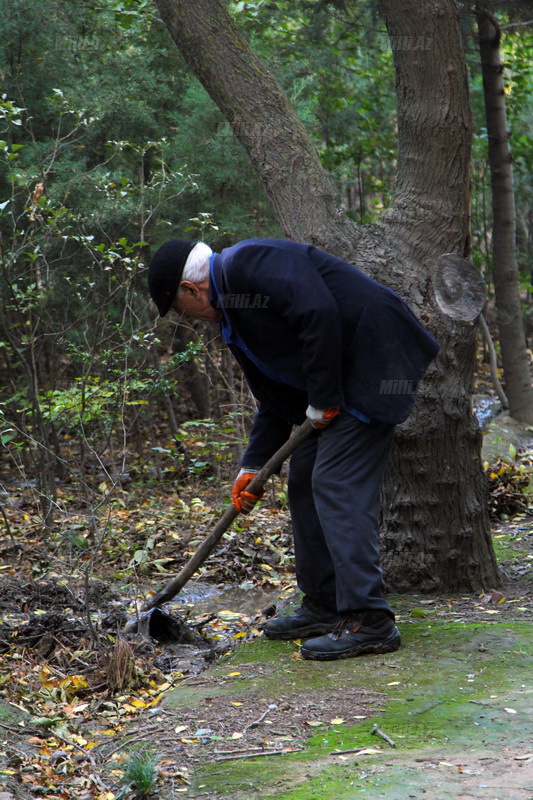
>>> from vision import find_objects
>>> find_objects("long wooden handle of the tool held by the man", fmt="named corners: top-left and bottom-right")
top-left (143, 419), bottom-right (314, 611)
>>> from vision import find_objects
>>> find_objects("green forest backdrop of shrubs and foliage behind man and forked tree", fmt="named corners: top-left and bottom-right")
top-left (0, 0), bottom-right (533, 588)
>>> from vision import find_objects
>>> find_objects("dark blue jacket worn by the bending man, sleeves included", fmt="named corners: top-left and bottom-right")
top-left (211, 239), bottom-right (439, 466)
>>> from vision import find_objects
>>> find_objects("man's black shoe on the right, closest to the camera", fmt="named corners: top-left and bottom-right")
top-left (301, 611), bottom-right (401, 661)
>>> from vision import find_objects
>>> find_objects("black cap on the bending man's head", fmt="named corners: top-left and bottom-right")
top-left (148, 239), bottom-right (197, 317)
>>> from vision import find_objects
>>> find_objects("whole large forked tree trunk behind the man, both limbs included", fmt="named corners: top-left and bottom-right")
top-left (155, 0), bottom-right (498, 591)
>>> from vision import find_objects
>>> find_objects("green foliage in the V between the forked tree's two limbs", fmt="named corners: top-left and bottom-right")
top-left (231, 1), bottom-right (397, 223)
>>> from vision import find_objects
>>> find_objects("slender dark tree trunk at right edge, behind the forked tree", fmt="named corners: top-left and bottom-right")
top-left (476, 6), bottom-right (533, 423)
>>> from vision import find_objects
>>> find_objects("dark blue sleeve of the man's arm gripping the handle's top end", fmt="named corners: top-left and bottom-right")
top-left (226, 245), bottom-right (343, 408)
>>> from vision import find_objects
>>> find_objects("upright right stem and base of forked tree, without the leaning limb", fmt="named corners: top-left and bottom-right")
top-left (374, 0), bottom-right (498, 591)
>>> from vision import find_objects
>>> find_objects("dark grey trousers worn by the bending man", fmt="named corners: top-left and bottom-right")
top-left (289, 411), bottom-right (395, 615)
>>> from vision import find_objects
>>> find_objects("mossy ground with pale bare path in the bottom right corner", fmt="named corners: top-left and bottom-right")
top-left (177, 619), bottom-right (533, 800)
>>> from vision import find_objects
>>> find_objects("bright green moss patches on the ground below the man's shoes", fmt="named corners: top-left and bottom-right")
top-left (191, 619), bottom-right (533, 800)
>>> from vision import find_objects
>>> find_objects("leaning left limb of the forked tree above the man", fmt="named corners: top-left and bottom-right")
top-left (155, 0), bottom-right (358, 252)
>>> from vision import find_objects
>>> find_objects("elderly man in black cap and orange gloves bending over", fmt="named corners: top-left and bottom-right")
top-left (148, 239), bottom-right (438, 660)
